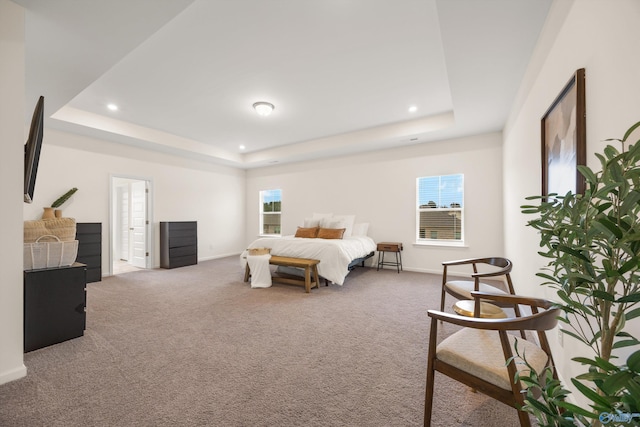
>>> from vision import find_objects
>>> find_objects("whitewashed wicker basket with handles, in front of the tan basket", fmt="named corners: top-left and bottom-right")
top-left (23, 234), bottom-right (78, 270)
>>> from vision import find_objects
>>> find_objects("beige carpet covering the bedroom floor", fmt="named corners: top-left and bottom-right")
top-left (0, 257), bottom-right (518, 427)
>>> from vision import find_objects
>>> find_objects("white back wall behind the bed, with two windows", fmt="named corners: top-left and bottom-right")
top-left (246, 133), bottom-right (503, 273)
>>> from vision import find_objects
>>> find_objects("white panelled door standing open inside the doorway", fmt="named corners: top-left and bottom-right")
top-left (129, 181), bottom-right (147, 268)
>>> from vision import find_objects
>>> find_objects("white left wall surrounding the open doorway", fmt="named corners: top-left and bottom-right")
top-left (24, 128), bottom-right (245, 274)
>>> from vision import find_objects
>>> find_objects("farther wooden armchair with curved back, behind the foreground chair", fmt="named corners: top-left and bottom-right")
top-left (440, 257), bottom-right (520, 317)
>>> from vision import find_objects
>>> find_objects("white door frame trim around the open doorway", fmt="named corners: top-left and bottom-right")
top-left (109, 174), bottom-right (155, 276)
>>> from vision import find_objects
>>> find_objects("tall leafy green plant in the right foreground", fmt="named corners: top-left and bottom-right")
top-left (521, 122), bottom-right (640, 425)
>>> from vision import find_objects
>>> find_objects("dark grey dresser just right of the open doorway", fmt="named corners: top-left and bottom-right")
top-left (160, 221), bottom-right (198, 268)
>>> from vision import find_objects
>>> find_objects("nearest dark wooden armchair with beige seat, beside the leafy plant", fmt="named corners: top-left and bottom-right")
top-left (424, 292), bottom-right (560, 427)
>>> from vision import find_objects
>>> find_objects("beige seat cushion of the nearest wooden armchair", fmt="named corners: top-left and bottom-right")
top-left (436, 328), bottom-right (548, 390)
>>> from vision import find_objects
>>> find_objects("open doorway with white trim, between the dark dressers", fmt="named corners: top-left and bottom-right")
top-left (110, 176), bottom-right (152, 275)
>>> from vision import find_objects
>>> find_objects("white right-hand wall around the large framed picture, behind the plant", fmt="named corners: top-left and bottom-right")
top-left (504, 0), bottom-right (640, 402)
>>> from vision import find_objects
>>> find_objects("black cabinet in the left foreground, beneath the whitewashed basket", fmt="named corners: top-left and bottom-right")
top-left (24, 263), bottom-right (87, 352)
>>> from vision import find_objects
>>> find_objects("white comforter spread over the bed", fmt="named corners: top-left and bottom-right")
top-left (248, 236), bottom-right (376, 285)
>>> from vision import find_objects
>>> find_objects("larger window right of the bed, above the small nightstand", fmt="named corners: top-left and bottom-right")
top-left (416, 174), bottom-right (464, 243)
